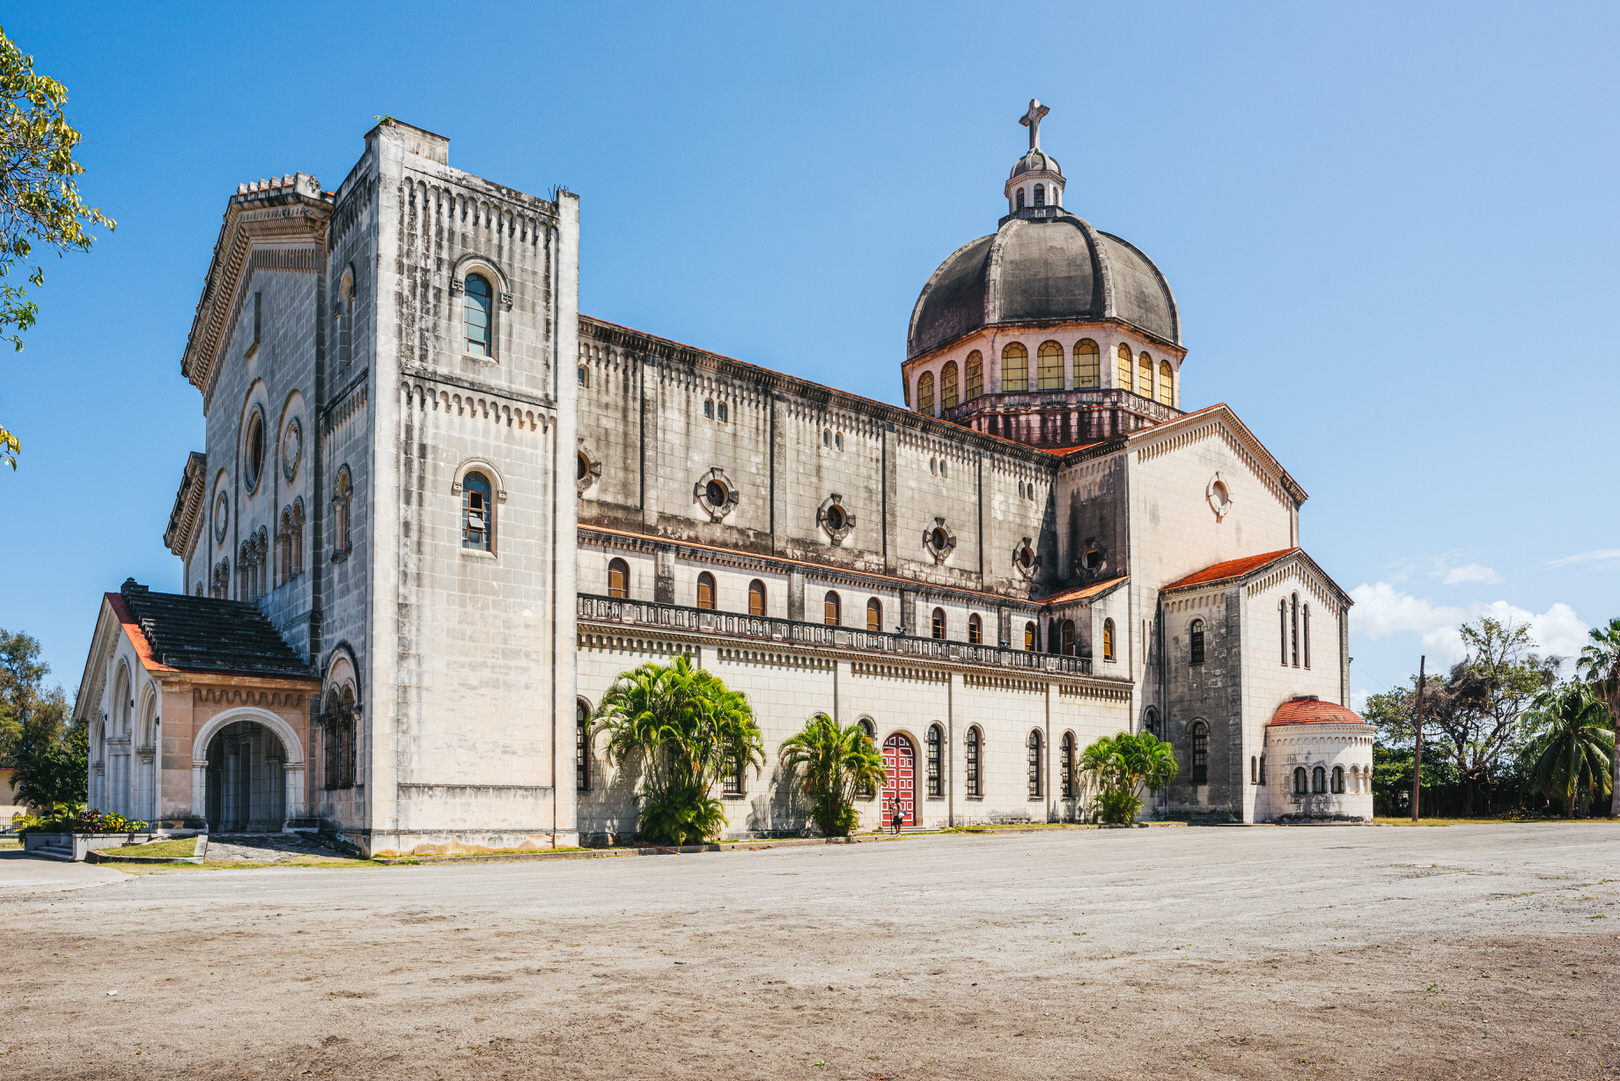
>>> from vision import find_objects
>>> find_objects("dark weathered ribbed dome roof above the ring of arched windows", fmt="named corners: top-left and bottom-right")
top-left (906, 214), bottom-right (1181, 360)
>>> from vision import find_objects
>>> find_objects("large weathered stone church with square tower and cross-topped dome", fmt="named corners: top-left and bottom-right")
top-left (75, 102), bottom-right (1372, 854)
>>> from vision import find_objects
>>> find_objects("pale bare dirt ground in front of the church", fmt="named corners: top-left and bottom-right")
top-left (0, 823), bottom-right (1620, 1081)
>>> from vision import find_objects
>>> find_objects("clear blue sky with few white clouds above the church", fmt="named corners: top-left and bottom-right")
top-left (0, 3), bottom-right (1620, 706)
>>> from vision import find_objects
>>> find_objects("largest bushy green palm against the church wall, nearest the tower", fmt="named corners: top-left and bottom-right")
top-left (591, 655), bottom-right (765, 844)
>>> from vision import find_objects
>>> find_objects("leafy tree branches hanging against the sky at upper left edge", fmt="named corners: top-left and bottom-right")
top-left (0, 29), bottom-right (117, 470)
